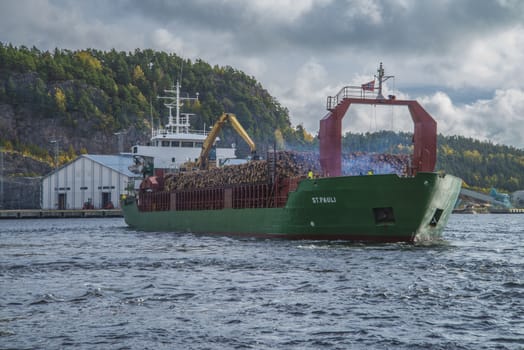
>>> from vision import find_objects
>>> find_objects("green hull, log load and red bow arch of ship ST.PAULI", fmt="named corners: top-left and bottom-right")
top-left (122, 64), bottom-right (462, 243)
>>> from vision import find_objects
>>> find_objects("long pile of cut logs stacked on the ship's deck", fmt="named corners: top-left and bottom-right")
top-left (164, 151), bottom-right (409, 191)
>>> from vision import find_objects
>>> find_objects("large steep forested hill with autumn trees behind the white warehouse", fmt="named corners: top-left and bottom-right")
top-left (0, 43), bottom-right (311, 162)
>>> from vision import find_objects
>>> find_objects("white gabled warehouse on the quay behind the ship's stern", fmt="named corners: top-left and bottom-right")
top-left (41, 154), bottom-right (138, 209)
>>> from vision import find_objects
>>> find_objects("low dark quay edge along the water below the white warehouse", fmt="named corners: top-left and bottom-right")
top-left (0, 209), bottom-right (123, 219)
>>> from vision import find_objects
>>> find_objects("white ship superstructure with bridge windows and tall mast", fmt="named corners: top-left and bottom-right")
top-left (131, 81), bottom-right (236, 170)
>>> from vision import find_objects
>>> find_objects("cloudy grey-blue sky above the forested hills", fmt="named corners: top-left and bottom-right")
top-left (0, 0), bottom-right (524, 149)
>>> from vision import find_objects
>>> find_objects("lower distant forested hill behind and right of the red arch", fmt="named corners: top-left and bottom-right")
top-left (342, 131), bottom-right (524, 192)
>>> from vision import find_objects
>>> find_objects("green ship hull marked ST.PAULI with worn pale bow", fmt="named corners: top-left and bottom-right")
top-left (121, 172), bottom-right (462, 242)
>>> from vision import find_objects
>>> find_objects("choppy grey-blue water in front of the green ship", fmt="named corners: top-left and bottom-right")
top-left (0, 215), bottom-right (524, 349)
